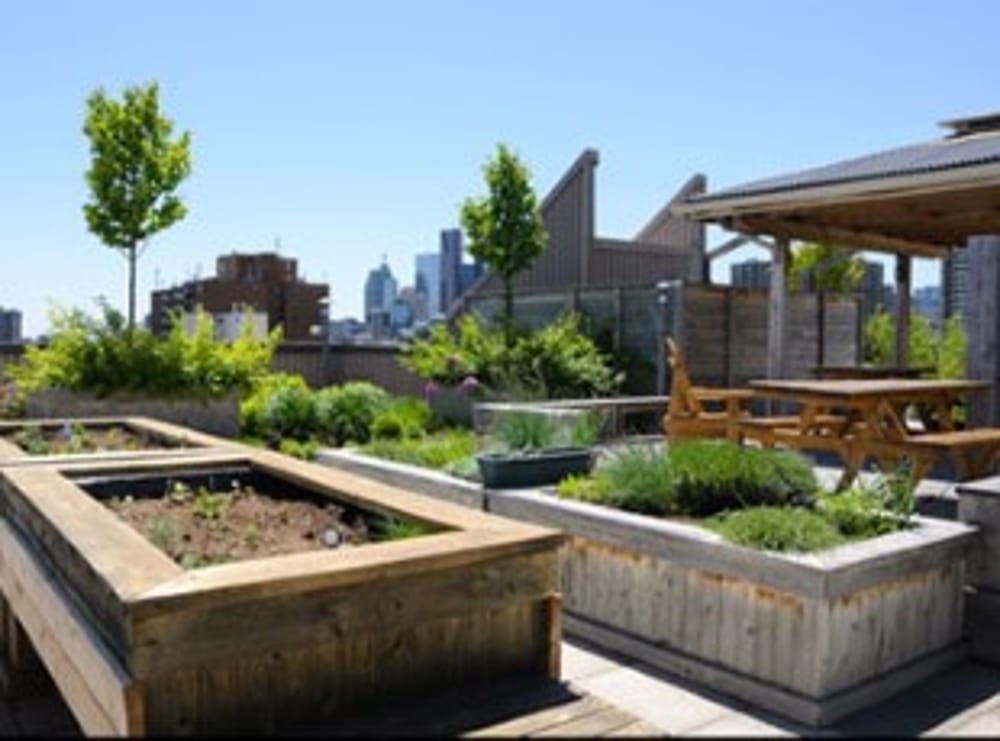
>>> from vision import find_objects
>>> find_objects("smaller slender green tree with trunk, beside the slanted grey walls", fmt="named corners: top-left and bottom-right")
top-left (462, 144), bottom-right (548, 351)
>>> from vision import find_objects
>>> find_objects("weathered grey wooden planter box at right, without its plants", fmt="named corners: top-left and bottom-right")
top-left (486, 490), bottom-right (975, 726)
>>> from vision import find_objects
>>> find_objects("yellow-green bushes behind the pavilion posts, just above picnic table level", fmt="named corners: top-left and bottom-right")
top-left (864, 310), bottom-right (966, 378)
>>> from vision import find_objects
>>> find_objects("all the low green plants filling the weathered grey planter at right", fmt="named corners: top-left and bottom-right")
top-left (557, 440), bottom-right (914, 552)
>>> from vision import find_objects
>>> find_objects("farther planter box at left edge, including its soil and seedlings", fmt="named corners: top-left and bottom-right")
top-left (0, 417), bottom-right (227, 464)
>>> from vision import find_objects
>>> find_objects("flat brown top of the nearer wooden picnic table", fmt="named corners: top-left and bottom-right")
top-left (749, 378), bottom-right (990, 402)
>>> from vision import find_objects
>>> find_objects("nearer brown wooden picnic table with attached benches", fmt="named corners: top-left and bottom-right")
top-left (741, 378), bottom-right (1000, 485)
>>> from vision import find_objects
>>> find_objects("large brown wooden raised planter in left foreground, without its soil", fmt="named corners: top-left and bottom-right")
top-left (0, 451), bottom-right (562, 735)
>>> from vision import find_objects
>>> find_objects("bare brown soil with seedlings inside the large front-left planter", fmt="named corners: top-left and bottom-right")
top-left (102, 482), bottom-right (373, 568)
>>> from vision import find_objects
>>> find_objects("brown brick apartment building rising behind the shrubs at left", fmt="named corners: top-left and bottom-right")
top-left (150, 252), bottom-right (330, 340)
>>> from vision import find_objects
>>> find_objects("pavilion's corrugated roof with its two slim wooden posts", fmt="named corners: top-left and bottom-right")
top-left (673, 113), bottom-right (1000, 378)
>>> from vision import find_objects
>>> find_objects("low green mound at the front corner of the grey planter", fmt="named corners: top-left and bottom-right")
top-left (703, 507), bottom-right (844, 552)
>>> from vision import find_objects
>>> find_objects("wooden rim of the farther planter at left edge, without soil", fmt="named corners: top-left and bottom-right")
top-left (0, 417), bottom-right (234, 466)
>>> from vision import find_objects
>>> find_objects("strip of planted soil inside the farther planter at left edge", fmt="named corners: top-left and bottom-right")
top-left (6, 424), bottom-right (186, 455)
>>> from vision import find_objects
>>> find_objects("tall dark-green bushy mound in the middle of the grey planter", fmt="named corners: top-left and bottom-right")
top-left (668, 440), bottom-right (819, 517)
